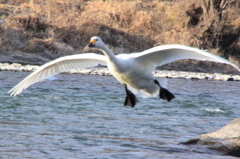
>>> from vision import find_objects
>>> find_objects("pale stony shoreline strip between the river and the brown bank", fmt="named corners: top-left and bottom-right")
top-left (0, 63), bottom-right (240, 81)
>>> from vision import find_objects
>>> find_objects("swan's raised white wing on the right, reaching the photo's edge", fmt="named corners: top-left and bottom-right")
top-left (132, 45), bottom-right (240, 72)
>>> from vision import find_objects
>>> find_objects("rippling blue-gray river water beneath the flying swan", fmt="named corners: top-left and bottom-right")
top-left (0, 71), bottom-right (240, 159)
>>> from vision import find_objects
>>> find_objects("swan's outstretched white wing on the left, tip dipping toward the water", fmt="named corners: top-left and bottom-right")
top-left (8, 53), bottom-right (107, 96)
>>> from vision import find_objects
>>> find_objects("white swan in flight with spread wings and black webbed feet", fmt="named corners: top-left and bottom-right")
top-left (9, 36), bottom-right (240, 107)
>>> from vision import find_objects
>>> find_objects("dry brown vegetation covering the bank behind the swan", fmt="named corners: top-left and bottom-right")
top-left (0, 0), bottom-right (240, 72)
